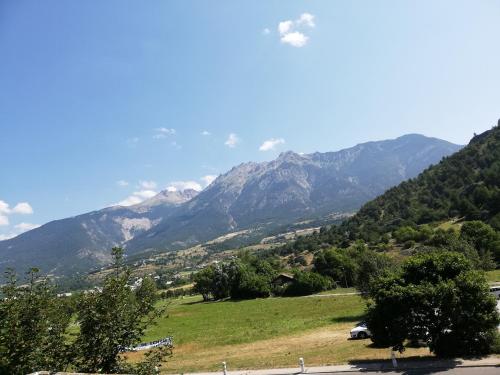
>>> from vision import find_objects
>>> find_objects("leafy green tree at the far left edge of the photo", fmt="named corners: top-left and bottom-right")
top-left (0, 268), bottom-right (71, 375)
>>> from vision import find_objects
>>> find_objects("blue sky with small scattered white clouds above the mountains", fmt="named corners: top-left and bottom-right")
top-left (0, 0), bottom-right (500, 239)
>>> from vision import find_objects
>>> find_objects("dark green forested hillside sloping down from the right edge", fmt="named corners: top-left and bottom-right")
top-left (285, 121), bottom-right (500, 262)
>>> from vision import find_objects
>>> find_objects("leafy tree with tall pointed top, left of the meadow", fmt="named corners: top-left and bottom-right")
top-left (74, 248), bottom-right (166, 373)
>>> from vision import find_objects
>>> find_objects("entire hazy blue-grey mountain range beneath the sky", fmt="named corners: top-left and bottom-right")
top-left (0, 134), bottom-right (462, 274)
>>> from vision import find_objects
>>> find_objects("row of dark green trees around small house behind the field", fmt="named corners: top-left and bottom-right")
top-left (193, 242), bottom-right (396, 300)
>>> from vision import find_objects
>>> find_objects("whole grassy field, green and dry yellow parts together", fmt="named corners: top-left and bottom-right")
top-left (125, 295), bottom-right (428, 373)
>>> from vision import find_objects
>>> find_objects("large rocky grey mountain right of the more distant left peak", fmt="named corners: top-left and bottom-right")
top-left (127, 134), bottom-right (460, 251)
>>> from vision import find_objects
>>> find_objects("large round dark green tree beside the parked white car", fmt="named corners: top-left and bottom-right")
top-left (367, 252), bottom-right (500, 356)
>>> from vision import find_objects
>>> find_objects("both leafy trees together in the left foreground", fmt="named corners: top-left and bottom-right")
top-left (0, 248), bottom-right (170, 375)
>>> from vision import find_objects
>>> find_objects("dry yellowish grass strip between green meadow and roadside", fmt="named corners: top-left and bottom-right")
top-left (129, 323), bottom-right (429, 373)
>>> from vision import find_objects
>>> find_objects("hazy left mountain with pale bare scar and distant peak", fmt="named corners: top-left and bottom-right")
top-left (0, 190), bottom-right (197, 272)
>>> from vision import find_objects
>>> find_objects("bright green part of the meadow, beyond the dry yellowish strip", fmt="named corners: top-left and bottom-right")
top-left (144, 296), bottom-right (364, 345)
